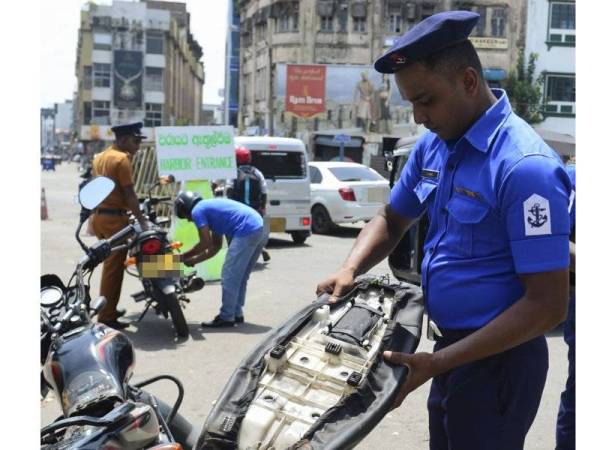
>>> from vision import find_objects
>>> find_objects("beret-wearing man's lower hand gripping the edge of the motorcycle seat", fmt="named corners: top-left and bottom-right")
top-left (383, 351), bottom-right (438, 411)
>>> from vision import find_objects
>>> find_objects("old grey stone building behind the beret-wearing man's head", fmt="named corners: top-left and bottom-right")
top-left (238, 0), bottom-right (527, 142)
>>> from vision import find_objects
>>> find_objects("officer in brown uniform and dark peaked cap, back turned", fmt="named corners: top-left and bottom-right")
top-left (92, 122), bottom-right (148, 329)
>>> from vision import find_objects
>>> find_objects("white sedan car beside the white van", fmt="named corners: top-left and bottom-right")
top-left (308, 161), bottom-right (390, 233)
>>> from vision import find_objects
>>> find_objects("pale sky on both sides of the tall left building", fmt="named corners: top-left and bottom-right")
top-left (40, 0), bottom-right (228, 107)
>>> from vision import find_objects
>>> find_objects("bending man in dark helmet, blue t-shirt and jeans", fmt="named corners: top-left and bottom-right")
top-left (173, 191), bottom-right (263, 328)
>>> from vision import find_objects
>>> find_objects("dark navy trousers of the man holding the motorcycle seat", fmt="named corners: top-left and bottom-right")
top-left (427, 331), bottom-right (548, 450)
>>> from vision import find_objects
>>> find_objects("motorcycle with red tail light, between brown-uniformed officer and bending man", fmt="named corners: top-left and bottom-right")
top-left (126, 175), bottom-right (204, 338)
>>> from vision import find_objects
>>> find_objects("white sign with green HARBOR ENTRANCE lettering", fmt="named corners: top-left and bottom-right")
top-left (155, 126), bottom-right (237, 181)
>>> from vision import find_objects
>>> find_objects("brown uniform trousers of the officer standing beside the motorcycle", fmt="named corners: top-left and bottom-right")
top-left (90, 214), bottom-right (129, 322)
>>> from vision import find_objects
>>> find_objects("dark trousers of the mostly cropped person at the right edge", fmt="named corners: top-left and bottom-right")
top-left (556, 294), bottom-right (575, 450)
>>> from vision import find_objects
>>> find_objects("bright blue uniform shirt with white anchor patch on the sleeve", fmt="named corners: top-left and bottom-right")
top-left (390, 89), bottom-right (571, 329)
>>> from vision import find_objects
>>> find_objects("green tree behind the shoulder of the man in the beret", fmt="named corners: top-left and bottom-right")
top-left (503, 49), bottom-right (544, 124)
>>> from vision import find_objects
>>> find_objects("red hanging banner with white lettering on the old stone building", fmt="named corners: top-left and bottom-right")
top-left (285, 64), bottom-right (327, 118)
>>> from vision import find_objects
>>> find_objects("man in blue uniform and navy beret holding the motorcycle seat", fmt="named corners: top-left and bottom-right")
top-left (317, 11), bottom-right (571, 450)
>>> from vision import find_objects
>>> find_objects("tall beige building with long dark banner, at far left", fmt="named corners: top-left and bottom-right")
top-left (74, 0), bottom-right (204, 145)
